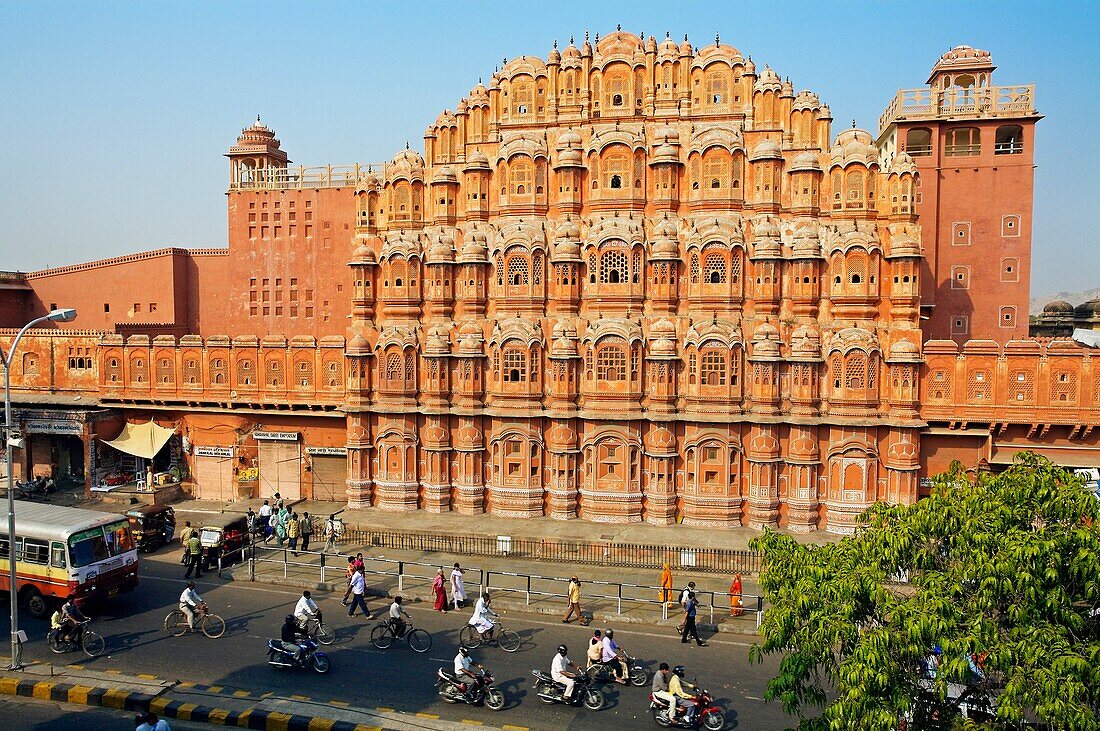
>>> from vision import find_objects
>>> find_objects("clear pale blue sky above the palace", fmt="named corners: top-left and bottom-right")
top-left (0, 0), bottom-right (1100, 295)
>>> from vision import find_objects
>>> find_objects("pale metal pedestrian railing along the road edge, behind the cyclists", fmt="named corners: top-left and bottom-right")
top-left (244, 543), bottom-right (763, 628)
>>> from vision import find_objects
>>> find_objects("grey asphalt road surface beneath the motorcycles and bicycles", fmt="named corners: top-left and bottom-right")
top-left (0, 547), bottom-right (790, 730)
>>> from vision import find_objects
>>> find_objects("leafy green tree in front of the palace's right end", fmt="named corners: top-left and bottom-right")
top-left (751, 453), bottom-right (1100, 730)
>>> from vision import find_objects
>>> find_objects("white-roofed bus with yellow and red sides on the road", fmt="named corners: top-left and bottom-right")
top-left (0, 500), bottom-right (138, 618)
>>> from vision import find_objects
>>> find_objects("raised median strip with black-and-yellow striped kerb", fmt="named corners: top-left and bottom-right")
top-left (0, 664), bottom-right (527, 731)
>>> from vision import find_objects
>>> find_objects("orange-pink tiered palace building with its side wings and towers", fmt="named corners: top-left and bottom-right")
top-left (0, 31), bottom-right (1100, 532)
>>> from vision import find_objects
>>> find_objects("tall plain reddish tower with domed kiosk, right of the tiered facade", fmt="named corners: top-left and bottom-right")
top-left (878, 46), bottom-right (1042, 344)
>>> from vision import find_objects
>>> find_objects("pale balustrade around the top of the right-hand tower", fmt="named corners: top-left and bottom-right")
top-left (879, 84), bottom-right (1035, 131)
